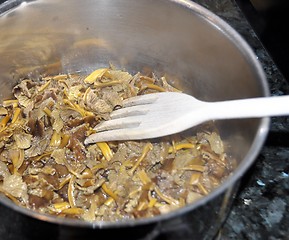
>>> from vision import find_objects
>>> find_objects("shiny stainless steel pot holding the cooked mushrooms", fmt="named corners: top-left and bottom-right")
top-left (0, 0), bottom-right (269, 239)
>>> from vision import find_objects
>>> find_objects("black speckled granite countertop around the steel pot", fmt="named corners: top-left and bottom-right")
top-left (0, 0), bottom-right (289, 240)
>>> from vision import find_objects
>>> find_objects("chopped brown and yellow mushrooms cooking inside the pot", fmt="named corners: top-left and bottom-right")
top-left (0, 67), bottom-right (232, 221)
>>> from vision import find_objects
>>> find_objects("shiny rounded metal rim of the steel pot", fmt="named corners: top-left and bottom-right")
top-left (0, 0), bottom-right (270, 229)
